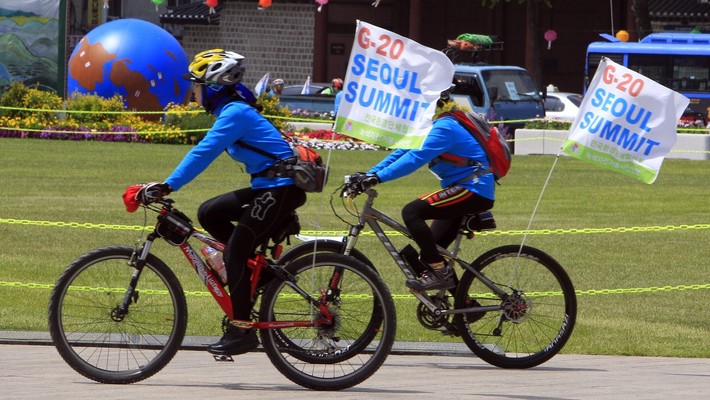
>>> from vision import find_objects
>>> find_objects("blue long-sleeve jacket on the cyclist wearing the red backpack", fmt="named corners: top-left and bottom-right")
top-left (368, 116), bottom-right (495, 200)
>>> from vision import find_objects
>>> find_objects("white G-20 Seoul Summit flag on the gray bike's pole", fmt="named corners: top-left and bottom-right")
top-left (562, 57), bottom-right (690, 184)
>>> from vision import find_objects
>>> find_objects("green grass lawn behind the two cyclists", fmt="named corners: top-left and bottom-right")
top-left (0, 139), bottom-right (710, 357)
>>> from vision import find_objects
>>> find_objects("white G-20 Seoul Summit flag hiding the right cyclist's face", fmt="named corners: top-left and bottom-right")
top-left (335, 21), bottom-right (454, 149)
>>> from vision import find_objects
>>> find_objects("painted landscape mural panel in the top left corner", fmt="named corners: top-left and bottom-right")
top-left (0, 0), bottom-right (65, 94)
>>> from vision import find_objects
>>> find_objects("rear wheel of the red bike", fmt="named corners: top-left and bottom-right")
top-left (259, 253), bottom-right (396, 390)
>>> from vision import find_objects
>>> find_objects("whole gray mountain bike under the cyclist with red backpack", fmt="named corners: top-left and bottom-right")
top-left (279, 177), bottom-right (577, 368)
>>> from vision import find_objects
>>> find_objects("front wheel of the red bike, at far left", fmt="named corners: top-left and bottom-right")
top-left (49, 246), bottom-right (187, 384)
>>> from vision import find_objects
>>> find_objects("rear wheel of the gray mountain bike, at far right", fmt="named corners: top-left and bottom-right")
top-left (454, 245), bottom-right (577, 369)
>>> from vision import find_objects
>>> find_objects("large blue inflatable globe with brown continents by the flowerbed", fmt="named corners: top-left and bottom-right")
top-left (67, 19), bottom-right (190, 118)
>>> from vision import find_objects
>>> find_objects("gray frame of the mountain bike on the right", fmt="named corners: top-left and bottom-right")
top-left (344, 188), bottom-right (508, 315)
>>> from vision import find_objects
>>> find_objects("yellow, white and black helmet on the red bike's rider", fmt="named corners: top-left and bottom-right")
top-left (185, 49), bottom-right (245, 86)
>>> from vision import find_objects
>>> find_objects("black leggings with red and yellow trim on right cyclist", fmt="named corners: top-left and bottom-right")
top-left (402, 185), bottom-right (493, 264)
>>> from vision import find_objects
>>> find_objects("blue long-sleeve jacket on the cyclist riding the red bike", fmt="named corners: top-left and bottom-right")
top-left (165, 101), bottom-right (293, 190)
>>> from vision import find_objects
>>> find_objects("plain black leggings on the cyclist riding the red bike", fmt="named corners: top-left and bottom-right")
top-left (197, 185), bottom-right (306, 321)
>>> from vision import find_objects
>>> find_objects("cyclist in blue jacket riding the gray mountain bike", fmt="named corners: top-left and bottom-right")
top-left (351, 91), bottom-right (496, 290)
